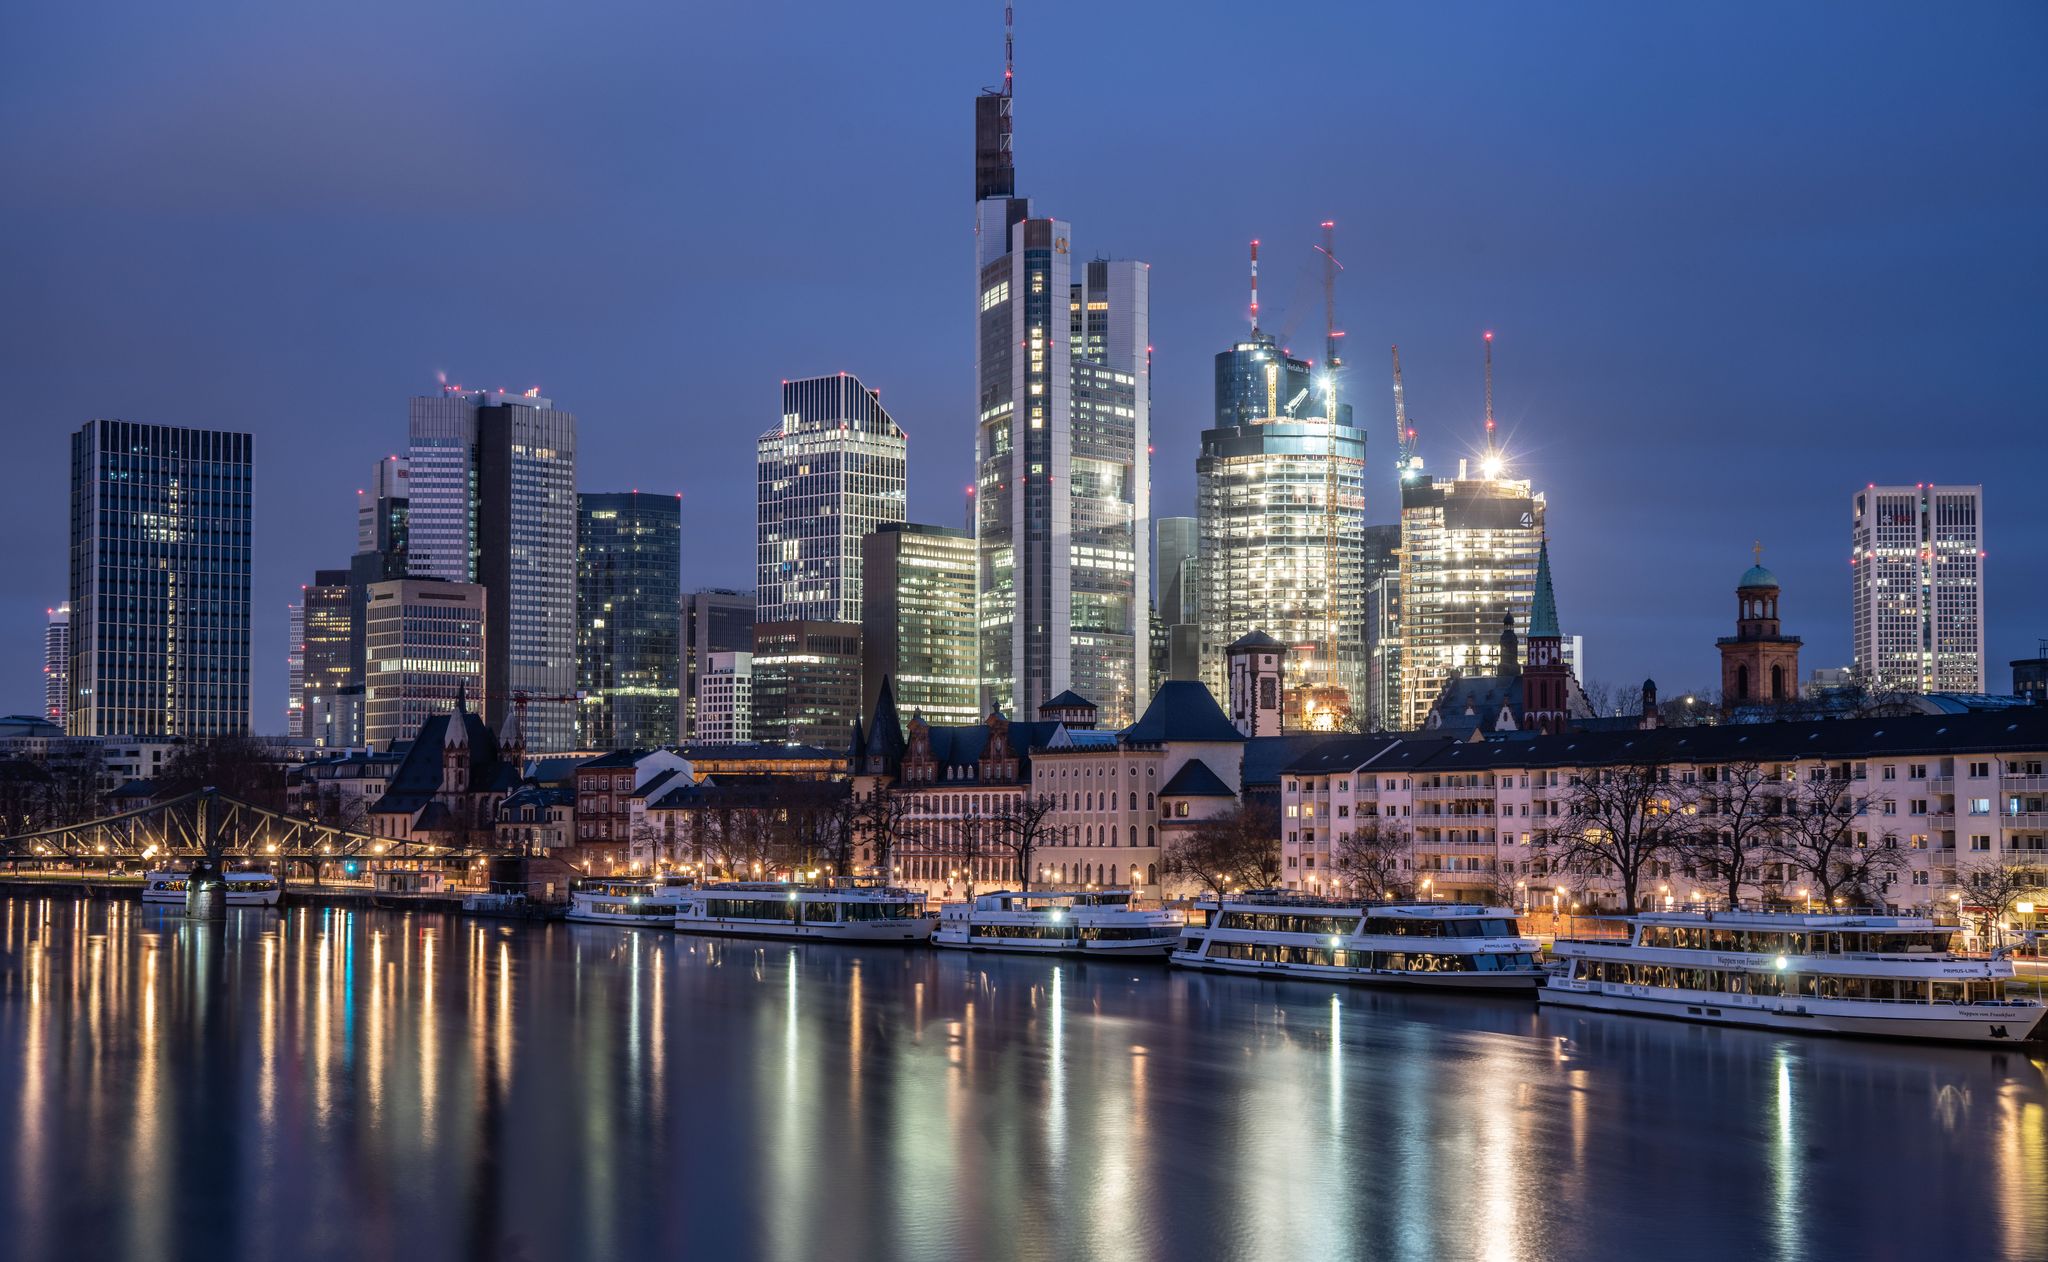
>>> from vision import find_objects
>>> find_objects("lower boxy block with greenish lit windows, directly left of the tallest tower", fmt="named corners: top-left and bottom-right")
top-left (860, 522), bottom-right (981, 725)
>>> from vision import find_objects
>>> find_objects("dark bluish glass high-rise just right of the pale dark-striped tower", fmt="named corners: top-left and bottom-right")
top-left (575, 492), bottom-right (682, 750)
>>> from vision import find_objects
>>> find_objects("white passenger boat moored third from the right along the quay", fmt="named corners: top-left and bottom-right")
top-left (932, 889), bottom-right (1186, 957)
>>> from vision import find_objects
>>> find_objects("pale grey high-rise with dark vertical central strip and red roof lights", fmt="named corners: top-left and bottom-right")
top-left (406, 385), bottom-right (575, 752)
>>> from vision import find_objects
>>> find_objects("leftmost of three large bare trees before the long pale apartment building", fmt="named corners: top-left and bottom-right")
top-left (1536, 760), bottom-right (1692, 912)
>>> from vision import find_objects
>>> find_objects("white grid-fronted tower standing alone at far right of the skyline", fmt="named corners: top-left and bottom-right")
top-left (1849, 483), bottom-right (1985, 692)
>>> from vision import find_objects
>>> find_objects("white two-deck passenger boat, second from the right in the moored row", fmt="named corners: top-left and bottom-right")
top-left (1169, 891), bottom-right (1544, 994)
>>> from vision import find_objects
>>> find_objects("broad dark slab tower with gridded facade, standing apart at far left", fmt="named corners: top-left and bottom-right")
top-left (66, 420), bottom-right (254, 738)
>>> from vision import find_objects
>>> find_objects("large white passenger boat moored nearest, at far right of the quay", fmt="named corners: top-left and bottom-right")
top-left (1538, 912), bottom-right (2044, 1043)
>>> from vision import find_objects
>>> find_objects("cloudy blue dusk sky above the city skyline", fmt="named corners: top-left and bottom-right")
top-left (0, 0), bottom-right (2048, 731)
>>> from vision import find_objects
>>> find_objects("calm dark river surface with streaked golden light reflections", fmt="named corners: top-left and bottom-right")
top-left (0, 899), bottom-right (2048, 1262)
